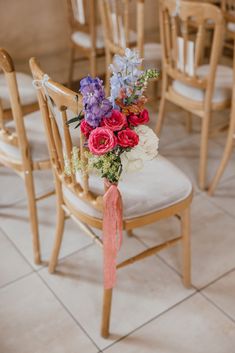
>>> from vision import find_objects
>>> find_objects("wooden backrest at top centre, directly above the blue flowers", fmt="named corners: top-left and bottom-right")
top-left (99, 0), bottom-right (143, 55)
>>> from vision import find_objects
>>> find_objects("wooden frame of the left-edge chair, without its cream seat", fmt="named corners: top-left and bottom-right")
top-left (0, 49), bottom-right (54, 264)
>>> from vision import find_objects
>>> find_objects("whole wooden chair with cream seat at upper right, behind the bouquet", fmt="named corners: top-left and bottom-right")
top-left (156, 0), bottom-right (232, 189)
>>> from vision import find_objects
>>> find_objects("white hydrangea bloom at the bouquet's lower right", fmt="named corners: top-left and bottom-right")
top-left (121, 125), bottom-right (159, 173)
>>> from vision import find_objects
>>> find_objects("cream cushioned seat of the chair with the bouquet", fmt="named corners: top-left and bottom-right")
top-left (63, 156), bottom-right (192, 219)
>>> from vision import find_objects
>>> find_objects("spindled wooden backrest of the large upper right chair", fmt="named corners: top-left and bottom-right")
top-left (160, 0), bottom-right (224, 99)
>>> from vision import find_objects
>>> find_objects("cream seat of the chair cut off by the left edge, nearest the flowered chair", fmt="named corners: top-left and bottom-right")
top-left (0, 111), bottom-right (49, 162)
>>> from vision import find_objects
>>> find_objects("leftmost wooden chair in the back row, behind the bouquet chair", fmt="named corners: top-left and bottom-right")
top-left (67, 0), bottom-right (104, 87)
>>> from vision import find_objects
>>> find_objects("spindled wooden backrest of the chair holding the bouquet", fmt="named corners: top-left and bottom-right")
top-left (30, 58), bottom-right (102, 210)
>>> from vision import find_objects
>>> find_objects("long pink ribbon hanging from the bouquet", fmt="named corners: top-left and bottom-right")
top-left (103, 181), bottom-right (122, 289)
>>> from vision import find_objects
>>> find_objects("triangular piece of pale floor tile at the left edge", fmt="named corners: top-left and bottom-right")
top-left (0, 230), bottom-right (32, 287)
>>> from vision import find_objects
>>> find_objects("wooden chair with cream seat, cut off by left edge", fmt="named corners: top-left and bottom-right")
top-left (0, 49), bottom-right (52, 264)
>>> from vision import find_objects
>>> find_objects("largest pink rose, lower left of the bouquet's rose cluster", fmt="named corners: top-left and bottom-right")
top-left (88, 127), bottom-right (117, 156)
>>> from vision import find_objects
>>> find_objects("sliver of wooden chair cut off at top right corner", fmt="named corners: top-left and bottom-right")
top-left (221, 0), bottom-right (235, 49)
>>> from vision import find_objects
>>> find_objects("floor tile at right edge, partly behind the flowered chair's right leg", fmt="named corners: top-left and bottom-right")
top-left (134, 194), bottom-right (235, 288)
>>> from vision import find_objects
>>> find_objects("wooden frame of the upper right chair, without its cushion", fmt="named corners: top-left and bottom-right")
top-left (156, 0), bottom-right (227, 189)
